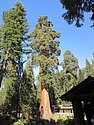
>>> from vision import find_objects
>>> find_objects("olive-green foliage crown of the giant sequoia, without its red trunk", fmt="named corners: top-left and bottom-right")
top-left (31, 16), bottom-right (61, 83)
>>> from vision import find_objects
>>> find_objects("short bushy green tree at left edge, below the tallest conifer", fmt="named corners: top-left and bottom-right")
top-left (0, 61), bottom-right (19, 113)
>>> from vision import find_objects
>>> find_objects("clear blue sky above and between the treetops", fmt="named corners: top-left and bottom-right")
top-left (0, 0), bottom-right (94, 68)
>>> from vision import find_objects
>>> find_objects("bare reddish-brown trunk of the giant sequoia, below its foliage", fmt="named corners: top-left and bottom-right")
top-left (40, 86), bottom-right (52, 120)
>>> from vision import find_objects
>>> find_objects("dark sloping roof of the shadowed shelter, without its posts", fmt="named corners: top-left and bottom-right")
top-left (60, 76), bottom-right (94, 102)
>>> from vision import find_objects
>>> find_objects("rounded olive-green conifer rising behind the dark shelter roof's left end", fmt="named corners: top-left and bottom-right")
top-left (63, 50), bottom-right (79, 92)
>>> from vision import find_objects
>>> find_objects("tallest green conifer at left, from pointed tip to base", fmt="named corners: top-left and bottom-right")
top-left (0, 2), bottom-right (28, 117)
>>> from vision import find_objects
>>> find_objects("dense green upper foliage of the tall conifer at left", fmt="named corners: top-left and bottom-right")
top-left (1, 2), bottom-right (28, 60)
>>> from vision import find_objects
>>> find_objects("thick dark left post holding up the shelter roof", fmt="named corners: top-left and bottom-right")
top-left (72, 99), bottom-right (85, 125)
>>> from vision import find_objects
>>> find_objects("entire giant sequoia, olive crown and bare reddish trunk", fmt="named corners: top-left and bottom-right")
top-left (31, 16), bottom-right (60, 119)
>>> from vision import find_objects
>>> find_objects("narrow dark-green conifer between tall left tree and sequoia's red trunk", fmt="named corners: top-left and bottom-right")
top-left (20, 61), bottom-right (37, 115)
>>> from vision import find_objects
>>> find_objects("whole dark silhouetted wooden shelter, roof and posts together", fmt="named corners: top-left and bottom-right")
top-left (60, 76), bottom-right (94, 125)
